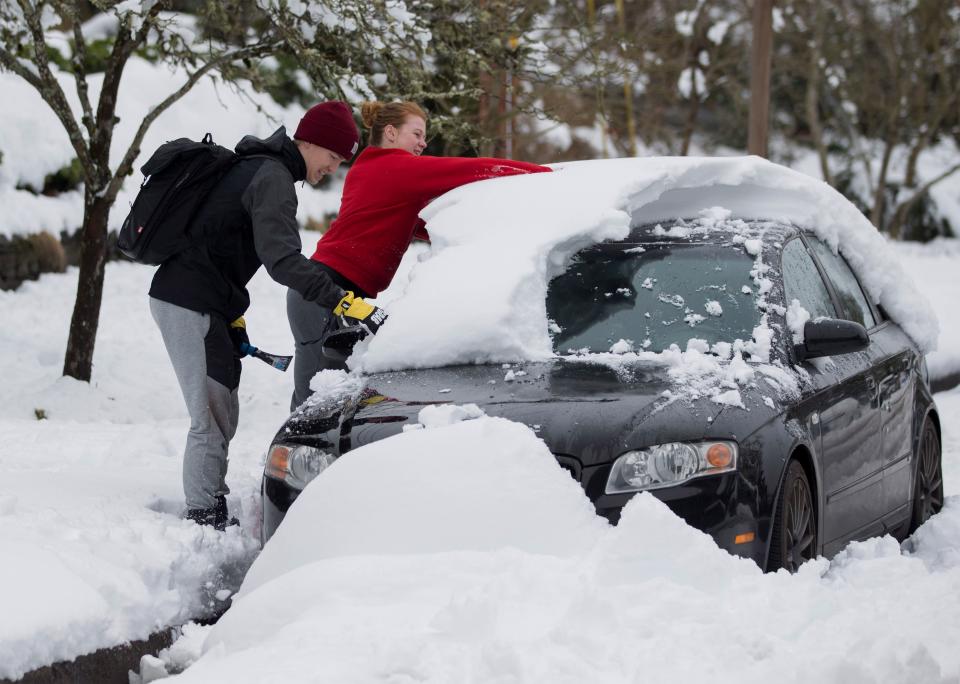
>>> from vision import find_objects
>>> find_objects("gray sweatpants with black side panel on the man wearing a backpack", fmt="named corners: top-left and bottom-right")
top-left (150, 297), bottom-right (240, 509)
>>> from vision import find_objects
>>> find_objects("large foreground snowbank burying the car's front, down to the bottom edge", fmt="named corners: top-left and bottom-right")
top-left (165, 408), bottom-right (960, 684)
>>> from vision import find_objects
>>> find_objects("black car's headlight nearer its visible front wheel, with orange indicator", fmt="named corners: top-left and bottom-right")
top-left (606, 442), bottom-right (737, 494)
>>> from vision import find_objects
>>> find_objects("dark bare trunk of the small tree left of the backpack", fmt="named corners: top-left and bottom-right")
top-left (63, 197), bottom-right (111, 382)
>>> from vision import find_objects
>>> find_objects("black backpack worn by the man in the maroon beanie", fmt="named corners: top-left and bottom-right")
top-left (117, 133), bottom-right (240, 266)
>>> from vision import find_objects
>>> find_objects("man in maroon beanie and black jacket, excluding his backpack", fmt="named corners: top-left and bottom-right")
top-left (150, 101), bottom-right (373, 530)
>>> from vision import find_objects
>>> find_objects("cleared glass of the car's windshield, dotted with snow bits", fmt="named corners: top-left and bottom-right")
top-left (547, 242), bottom-right (760, 354)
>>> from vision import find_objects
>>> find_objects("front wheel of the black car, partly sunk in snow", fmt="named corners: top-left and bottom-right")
top-left (767, 461), bottom-right (817, 572)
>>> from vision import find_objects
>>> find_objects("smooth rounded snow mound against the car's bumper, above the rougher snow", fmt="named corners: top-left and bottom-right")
top-left (240, 414), bottom-right (606, 596)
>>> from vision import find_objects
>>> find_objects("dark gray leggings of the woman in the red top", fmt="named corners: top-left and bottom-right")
top-left (287, 290), bottom-right (346, 411)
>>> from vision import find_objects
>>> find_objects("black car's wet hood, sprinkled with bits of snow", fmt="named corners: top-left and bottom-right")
top-left (281, 359), bottom-right (778, 466)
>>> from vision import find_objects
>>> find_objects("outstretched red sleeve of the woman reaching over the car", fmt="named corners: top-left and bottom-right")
top-left (394, 156), bottom-right (551, 200)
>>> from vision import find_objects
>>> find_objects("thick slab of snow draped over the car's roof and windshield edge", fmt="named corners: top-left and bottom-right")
top-left (358, 157), bottom-right (938, 380)
